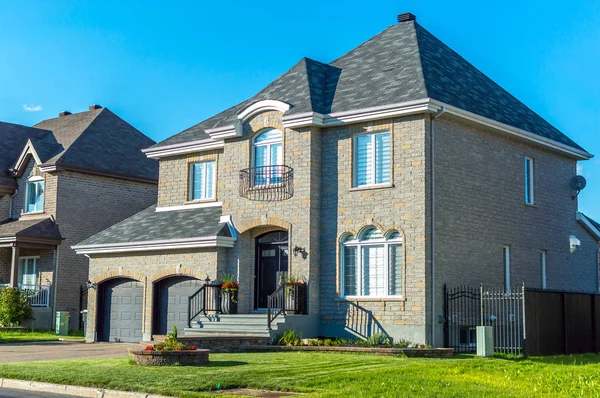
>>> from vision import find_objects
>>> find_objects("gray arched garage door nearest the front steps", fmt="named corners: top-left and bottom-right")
top-left (154, 277), bottom-right (204, 334)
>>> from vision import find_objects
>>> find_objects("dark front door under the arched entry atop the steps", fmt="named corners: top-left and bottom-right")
top-left (255, 231), bottom-right (289, 308)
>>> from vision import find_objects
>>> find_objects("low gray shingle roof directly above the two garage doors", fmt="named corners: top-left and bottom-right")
top-left (77, 205), bottom-right (231, 246)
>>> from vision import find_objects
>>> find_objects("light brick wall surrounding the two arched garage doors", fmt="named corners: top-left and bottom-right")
top-left (86, 248), bottom-right (226, 341)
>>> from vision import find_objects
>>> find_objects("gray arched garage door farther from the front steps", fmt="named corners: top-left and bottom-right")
top-left (99, 279), bottom-right (144, 342)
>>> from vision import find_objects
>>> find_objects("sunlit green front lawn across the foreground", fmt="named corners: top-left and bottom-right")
top-left (0, 352), bottom-right (600, 397)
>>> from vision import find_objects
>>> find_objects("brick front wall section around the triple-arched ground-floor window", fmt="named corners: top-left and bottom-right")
top-left (321, 116), bottom-right (428, 339)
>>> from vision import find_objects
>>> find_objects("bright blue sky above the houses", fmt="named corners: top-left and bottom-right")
top-left (0, 0), bottom-right (600, 220)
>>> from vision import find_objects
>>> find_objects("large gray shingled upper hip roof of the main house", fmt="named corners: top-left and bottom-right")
top-left (154, 21), bottom-right (582, 154)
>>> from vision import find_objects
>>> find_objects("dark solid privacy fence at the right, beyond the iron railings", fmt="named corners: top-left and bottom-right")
top-left (525, 289), bottom-right (600, 355)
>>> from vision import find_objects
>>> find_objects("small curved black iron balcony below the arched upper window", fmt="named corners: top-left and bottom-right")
top-left (239, 165), bottom-right (294, 202)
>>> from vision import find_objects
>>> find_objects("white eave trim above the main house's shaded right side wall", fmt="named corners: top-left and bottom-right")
top-left (431, 99), bottom-right (594, 160)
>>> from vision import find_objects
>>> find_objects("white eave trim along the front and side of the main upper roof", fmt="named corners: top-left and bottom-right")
top-left (144, 98), bottom-right (594, 160)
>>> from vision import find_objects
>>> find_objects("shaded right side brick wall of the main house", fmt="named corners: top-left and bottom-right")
top-left (435, 117), bottom-right (597, 333)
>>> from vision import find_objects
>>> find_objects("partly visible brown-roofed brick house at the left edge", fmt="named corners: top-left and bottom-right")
top-left (0, 105), bottom-right (158, 329)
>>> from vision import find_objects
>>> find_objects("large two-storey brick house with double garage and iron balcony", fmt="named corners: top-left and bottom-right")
top-left (75, 14), bottom-right (598, 345)
